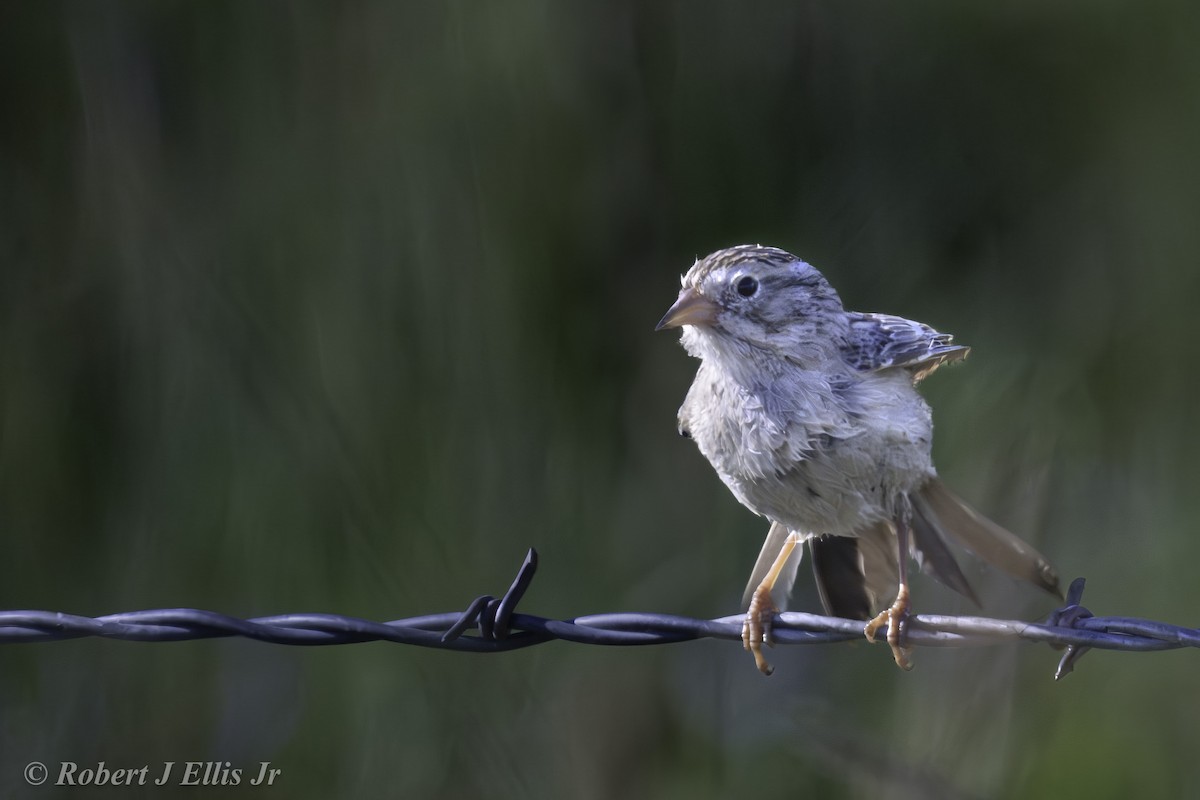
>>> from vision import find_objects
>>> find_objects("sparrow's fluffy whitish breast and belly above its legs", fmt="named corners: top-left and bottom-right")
top-left (680, 366), bottom-right (932, 535)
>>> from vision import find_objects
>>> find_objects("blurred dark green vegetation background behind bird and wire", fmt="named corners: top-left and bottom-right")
top-left (0, 0), bottom-right (1200, 800)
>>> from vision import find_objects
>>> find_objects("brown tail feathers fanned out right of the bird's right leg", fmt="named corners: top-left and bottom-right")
top-left (910, 477), bottom-right (1062, 603)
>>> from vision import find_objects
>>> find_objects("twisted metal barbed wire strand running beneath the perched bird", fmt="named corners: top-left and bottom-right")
top-left (0, 549), bottom-right (1200, 680)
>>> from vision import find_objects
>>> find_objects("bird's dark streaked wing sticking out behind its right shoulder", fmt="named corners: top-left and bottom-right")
top-left (842, 313), bottom-right (971, 383)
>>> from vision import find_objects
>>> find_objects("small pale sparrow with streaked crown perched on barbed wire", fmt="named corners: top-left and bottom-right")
top-left (655, 245), bottom-right (1062, 674)
